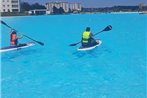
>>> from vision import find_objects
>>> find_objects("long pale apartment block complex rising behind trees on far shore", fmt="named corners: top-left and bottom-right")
top-left (46, 2), bottom-right (82, 13)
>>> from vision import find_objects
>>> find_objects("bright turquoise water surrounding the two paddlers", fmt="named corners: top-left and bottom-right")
top-left (1, 14), bottom-right (147, 98)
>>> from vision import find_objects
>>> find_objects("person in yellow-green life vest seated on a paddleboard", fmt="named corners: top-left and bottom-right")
top-left (81, 27), bottom-right (98, 47)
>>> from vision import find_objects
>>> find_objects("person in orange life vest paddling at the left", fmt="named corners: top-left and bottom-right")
top-left (10, 31), bottom-right (23, 46)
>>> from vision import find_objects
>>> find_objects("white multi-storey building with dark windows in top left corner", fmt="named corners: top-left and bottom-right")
top-left (0, 0), bottom-right (20, 12)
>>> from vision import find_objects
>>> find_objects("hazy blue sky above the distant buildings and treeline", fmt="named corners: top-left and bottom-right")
top-left (21, 0), bottom-right (147, 8)
